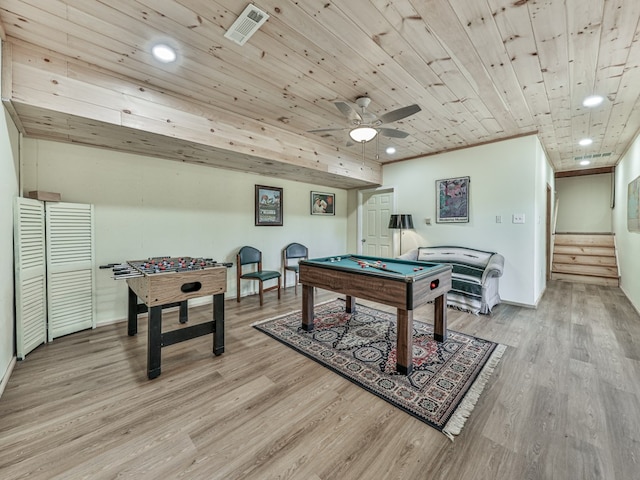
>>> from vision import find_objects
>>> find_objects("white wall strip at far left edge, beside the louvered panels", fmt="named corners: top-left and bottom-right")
top-left (0, 62), bottom-right (19, 386)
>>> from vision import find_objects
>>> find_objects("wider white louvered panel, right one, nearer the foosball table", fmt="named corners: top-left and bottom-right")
top-left (46, 202), bottom-right (95, 341)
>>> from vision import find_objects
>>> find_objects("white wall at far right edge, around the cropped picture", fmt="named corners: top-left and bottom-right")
top-left (613, 132), bottom-right (640, 312)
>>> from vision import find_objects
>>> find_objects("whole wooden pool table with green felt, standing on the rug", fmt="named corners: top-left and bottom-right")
top-left (299, 254), bottom-right (451, 375)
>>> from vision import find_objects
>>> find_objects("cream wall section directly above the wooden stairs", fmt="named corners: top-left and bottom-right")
top-left (556, 173), bottom-right (612, 233)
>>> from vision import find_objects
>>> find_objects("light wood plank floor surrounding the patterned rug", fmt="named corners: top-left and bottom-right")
top-left (0, 282), bottom-right (640, 480)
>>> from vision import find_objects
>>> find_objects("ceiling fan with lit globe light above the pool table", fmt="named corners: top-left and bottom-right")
top-left (309, 97), bottom-right (422, 146)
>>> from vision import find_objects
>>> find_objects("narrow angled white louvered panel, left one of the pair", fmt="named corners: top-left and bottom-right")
top-left (14, 197), bottom-right (47, 360)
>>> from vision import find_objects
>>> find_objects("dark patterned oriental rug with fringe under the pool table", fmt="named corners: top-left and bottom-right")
top-left (254, 299), bottom-right (506, 440)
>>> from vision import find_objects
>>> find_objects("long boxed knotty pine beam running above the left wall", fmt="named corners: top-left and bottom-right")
top-left (3, 41), bottom-right (382, 188)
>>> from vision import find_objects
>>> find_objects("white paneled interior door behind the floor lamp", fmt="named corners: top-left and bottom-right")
top-left (360, 190), bottom-right (393, 258)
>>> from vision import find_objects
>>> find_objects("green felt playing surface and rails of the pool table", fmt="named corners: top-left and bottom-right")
top-left (300, 254), bottom-right (451, 281)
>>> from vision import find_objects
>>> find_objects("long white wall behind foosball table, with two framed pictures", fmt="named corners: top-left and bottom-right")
top-left (22, 139), bottom-right (347, 324)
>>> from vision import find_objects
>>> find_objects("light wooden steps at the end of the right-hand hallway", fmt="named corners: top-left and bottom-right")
top-left (551, 233), bottom-right (620, 287)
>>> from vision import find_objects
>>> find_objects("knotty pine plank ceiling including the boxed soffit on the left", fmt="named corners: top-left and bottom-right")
top-left (0, 0), bottom-right (640, 188)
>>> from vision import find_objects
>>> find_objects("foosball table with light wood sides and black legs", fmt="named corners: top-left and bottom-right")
top-left (110, 257), bottom-right (231, 379)
